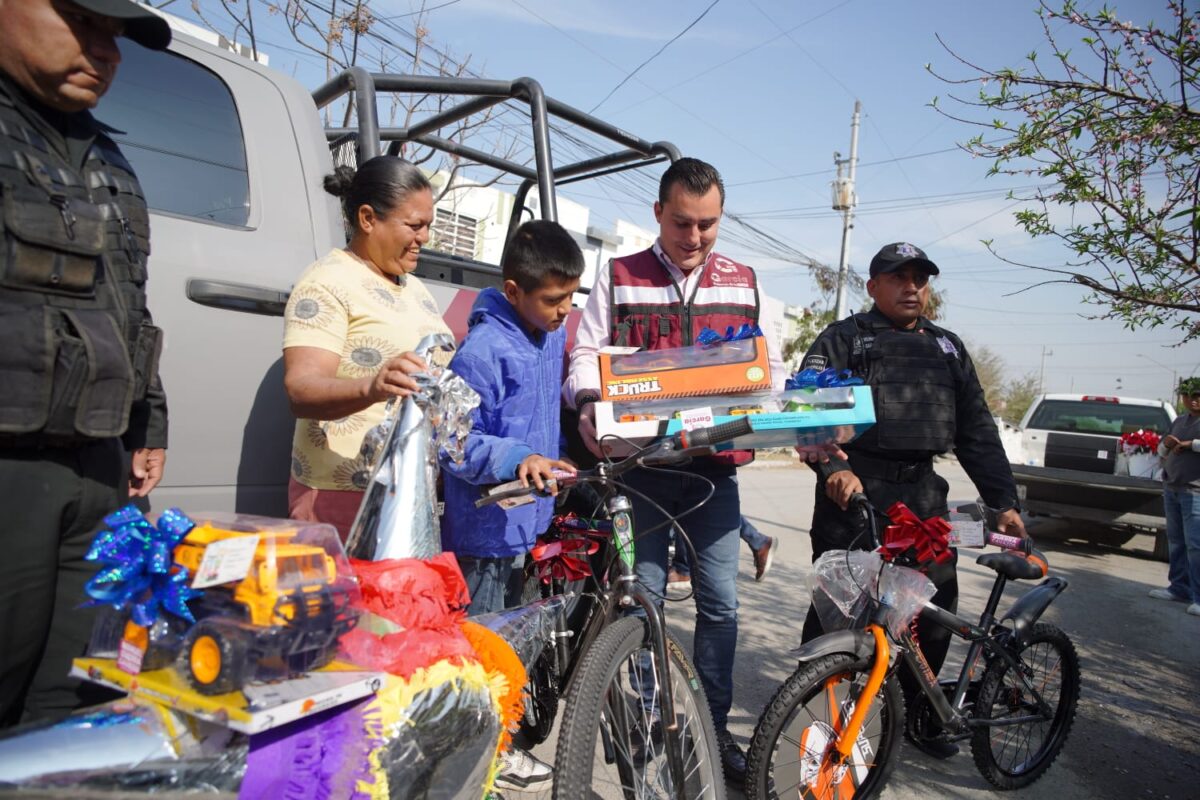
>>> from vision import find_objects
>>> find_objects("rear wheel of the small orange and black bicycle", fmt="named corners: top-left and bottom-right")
top-left (971, 622), bottom-right (1080, 789)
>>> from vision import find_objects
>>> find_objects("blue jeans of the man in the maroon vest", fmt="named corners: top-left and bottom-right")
top-left (625, 462), bottom-right (742, 730)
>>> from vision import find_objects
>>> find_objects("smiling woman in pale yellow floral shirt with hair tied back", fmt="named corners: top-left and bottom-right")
top-left (283, 156), bottom-right (450, 539)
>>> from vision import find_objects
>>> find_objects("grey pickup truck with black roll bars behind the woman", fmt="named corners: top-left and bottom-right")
top-left (95, 14), bottom-right (679, 517)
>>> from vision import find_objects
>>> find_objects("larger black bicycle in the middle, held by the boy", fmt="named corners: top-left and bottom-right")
top-left (476, 420), bottom-right (751, 800)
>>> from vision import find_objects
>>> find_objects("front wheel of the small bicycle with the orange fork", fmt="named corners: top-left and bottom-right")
top-left (745, 652), bottom-right (905, 800)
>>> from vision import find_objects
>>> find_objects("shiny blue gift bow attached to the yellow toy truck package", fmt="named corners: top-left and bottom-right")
top-left (84, 505), bottom-right (202, 627)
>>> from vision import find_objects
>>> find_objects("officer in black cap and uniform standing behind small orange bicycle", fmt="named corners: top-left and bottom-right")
top-left (803, 242), bottom-right (1025, 758)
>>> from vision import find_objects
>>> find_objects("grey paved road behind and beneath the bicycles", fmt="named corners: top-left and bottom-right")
top-left (508, 459), bottom-right (1200, 800)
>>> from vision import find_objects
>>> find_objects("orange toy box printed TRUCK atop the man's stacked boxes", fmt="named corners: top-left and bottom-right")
top-left (600, 336), bottom-right (770, 403)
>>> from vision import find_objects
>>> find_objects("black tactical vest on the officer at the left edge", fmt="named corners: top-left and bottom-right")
top-left (0, 90), bottom-right (162, 446)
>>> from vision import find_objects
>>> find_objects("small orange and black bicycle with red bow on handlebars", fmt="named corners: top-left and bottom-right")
top-left (746, 494), bottom-right (1080, 800)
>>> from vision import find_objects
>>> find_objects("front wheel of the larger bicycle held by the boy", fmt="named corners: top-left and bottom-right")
top-left (553, 616), bottom-right (725, 800)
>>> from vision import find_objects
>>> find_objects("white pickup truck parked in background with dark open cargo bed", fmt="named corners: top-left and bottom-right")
top-left (1006, 395), bottom-right (1175, 560)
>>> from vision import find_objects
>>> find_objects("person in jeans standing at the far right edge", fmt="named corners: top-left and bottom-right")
top-left (1150, 378), bottom-right (1200, 616)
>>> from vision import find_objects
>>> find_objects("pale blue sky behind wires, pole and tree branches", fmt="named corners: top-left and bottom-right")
top-left (174, 0), bottom-right (1200, 397)
